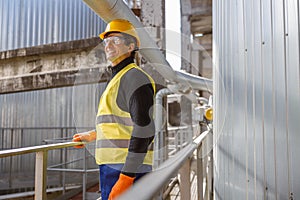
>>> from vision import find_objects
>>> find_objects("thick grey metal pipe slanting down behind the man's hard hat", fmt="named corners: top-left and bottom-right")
top-left (83, 0), bottom-right (213, 92)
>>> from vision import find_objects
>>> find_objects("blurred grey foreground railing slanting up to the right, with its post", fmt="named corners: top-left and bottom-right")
top-left (118, 131), bottom-right (210, 200)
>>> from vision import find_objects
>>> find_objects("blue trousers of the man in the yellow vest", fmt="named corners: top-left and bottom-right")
top-left (99, 164), bottom-right (152, 200)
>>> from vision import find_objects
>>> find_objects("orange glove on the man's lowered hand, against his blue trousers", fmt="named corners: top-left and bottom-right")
top-left (108, 174), bottom-right (134, 200)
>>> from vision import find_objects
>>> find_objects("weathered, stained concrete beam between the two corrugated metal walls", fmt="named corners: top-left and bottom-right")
top-left (0, 38), bottom-right (108, 94)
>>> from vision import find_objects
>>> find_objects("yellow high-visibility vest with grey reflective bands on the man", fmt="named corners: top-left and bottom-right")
top-left (95, 63), bottom-right (155, 165)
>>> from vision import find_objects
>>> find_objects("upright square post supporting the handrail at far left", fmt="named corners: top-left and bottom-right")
top-left (34, 151), bottom-right (48, 200)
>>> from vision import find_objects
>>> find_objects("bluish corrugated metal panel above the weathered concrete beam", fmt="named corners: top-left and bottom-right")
top-left (0, 0), bottom-right (105, 51)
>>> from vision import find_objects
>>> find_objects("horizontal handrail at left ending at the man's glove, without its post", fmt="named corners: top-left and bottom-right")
top-left (0, 142), bottom-right (84, 158)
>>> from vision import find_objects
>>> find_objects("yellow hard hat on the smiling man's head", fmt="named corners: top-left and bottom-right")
top-left (99, 19), bottom-right (140, 47)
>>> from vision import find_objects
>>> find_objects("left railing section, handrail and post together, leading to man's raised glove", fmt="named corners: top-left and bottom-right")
top-left (0, 142), bottom-right (83, 200)
